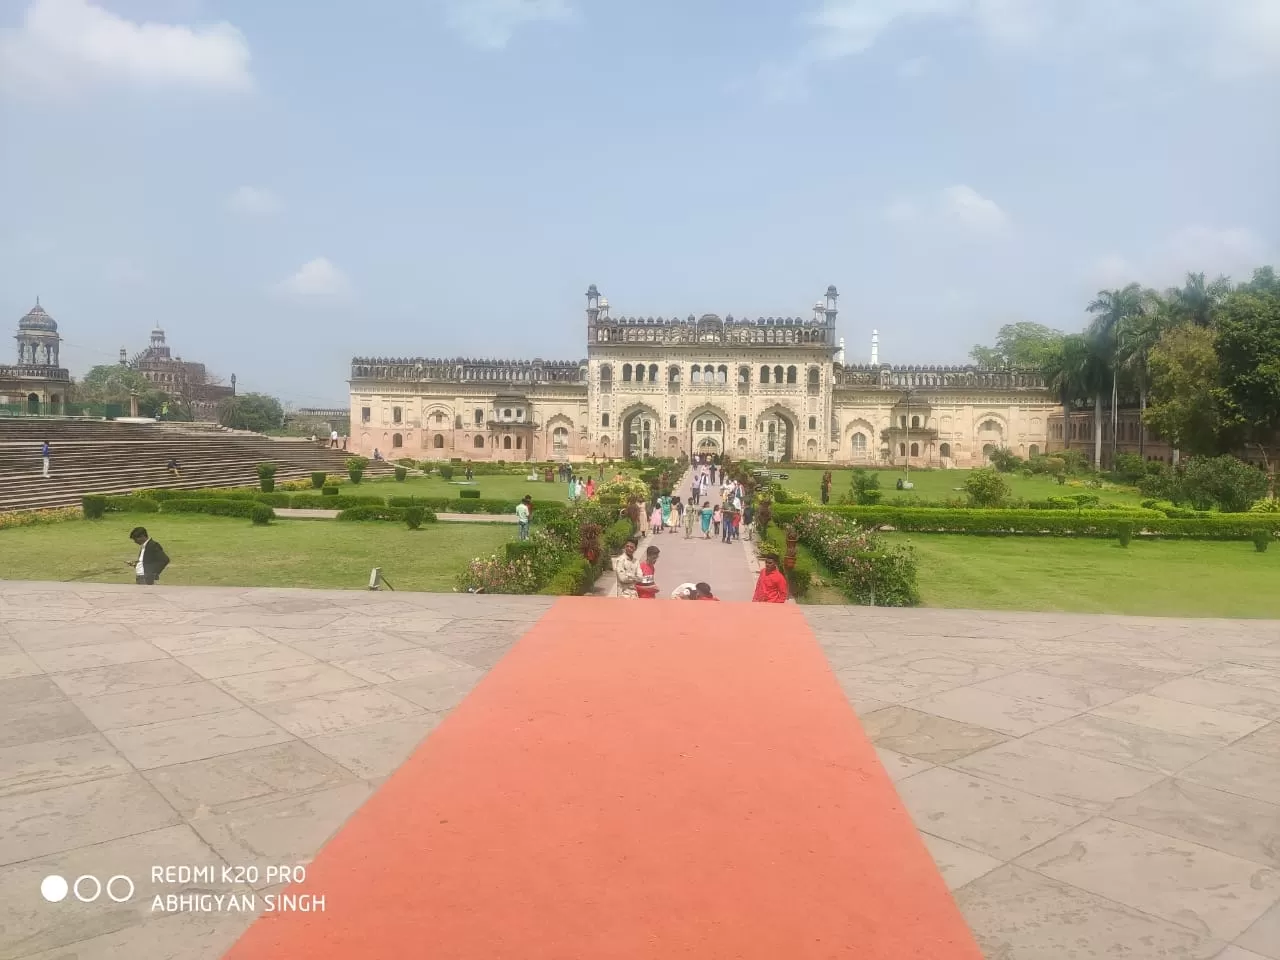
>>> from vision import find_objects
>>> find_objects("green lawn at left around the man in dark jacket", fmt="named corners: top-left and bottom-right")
top-left (0, 515), bottom-right (516, 593)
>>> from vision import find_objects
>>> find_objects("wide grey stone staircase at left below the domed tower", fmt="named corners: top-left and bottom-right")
top-left (0, 417), bottom-right (392, 512)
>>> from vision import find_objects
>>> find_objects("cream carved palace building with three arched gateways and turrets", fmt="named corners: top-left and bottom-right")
top-left (349, 284), bottom-right (1060, 467)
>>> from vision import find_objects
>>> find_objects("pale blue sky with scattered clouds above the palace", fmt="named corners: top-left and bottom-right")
top-left (0, 0), bottom-right (1280, 406)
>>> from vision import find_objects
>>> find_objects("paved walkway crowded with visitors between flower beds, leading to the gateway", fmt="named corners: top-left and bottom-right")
top-left (594, 470), bottom-right (758, 602)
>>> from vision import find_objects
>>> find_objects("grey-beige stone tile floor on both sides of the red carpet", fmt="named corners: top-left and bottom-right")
top-left (0, 578), bottom-right (1280, 960)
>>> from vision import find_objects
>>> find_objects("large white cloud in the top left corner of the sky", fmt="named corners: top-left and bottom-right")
top-left (0, 0), bottom-right (252, 95)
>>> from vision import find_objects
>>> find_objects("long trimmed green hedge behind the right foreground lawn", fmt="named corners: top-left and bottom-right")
top-left (773, 504), bottom-right (1280, 540)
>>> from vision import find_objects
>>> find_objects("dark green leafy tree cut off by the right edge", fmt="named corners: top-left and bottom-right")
top-left (1213, 289), bottom-right (1280, 478)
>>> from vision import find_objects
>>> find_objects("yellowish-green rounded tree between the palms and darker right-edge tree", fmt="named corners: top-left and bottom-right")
top-left (1146, 324), bottom-right (1222, 456)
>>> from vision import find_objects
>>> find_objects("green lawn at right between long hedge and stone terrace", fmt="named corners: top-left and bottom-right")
top-left (884, 534), bottom-right (1280, 617)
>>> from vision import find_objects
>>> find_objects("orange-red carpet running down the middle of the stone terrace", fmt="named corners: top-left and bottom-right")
top-left (228, 598), bottom-right (982, 960)
